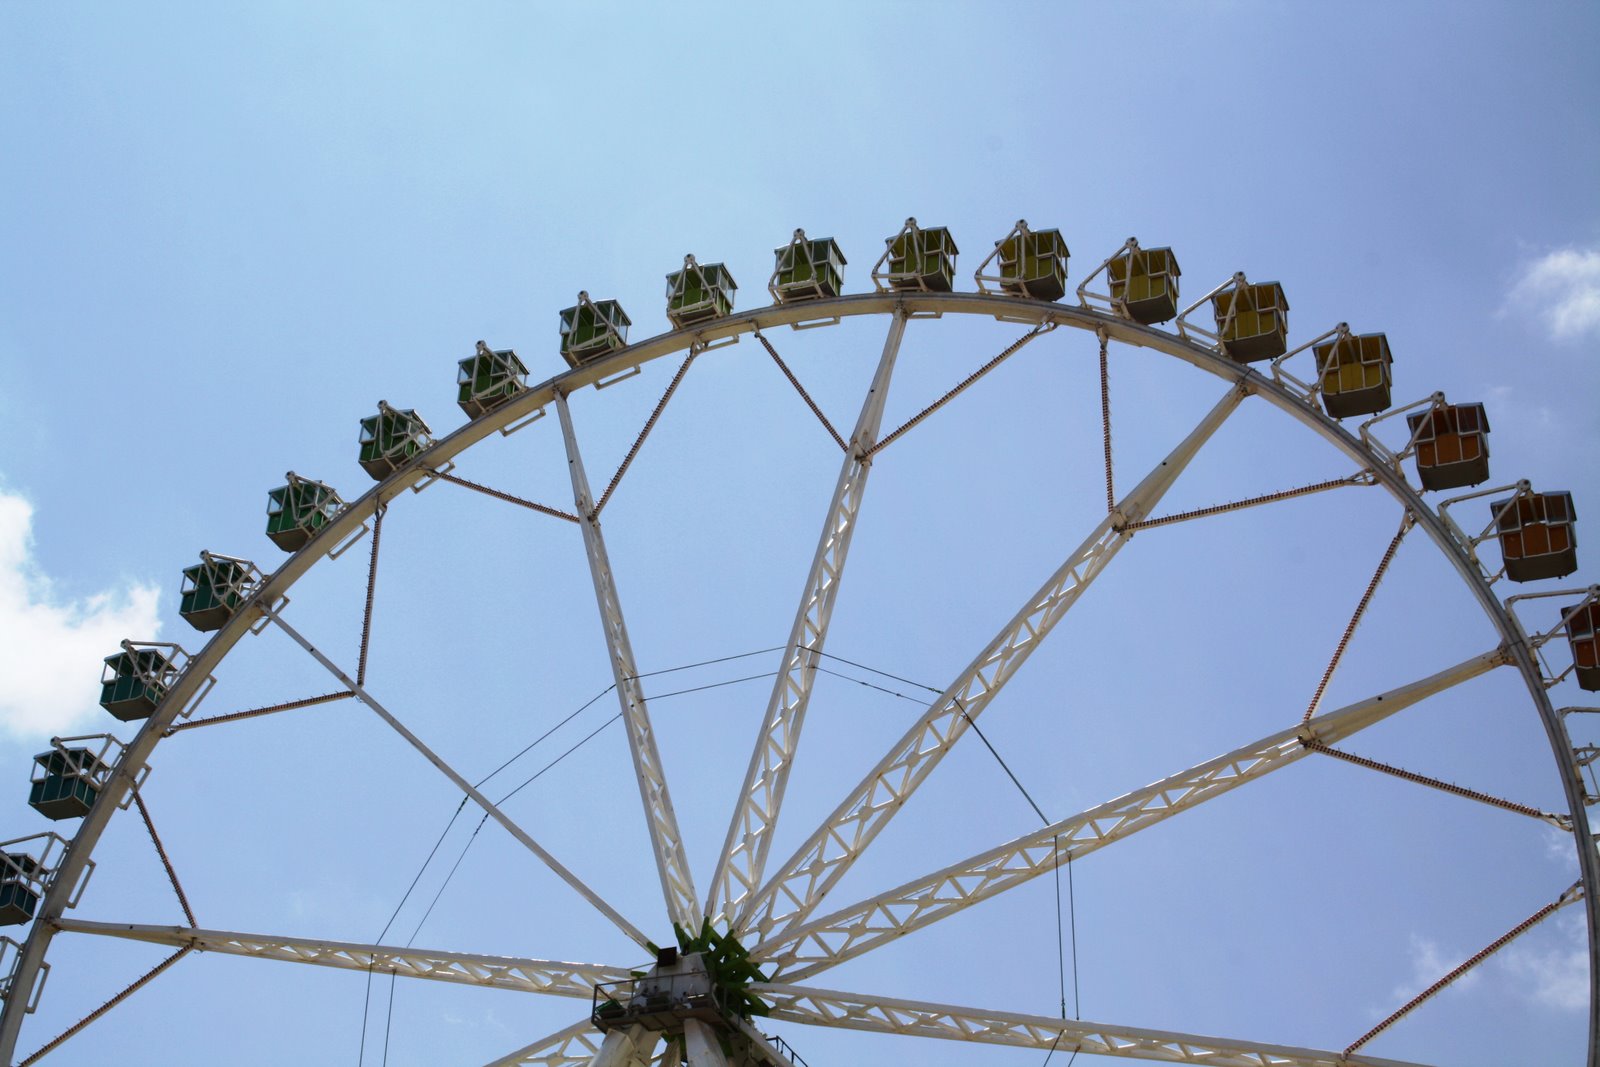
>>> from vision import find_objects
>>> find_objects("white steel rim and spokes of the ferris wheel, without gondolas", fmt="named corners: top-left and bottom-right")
top-left (0, 293), bottom-right (1600, 1067)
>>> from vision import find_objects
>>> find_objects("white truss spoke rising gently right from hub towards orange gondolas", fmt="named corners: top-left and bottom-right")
top-left (750, 649), bottom-right (1507, 981)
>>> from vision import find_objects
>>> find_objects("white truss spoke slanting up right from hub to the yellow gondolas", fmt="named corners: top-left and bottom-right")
top-left (736, 379), bottom-right (1245, 941)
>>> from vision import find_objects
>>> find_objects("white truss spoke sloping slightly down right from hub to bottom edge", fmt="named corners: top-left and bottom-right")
top-left (750, 984), bottom-right (1421, 1067)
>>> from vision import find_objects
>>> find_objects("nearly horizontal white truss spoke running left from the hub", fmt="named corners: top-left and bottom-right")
top-left (54, 918), bottom-right (629, 1000)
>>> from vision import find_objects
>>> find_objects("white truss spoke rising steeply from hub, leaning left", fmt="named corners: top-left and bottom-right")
top-left (555, 392), bottom-right (701, 929)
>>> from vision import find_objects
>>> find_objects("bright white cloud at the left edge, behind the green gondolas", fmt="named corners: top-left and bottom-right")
top-left (0, 491), bottom-right (160, 739)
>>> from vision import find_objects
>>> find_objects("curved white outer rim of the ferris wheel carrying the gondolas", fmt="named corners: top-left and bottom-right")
top-left (0, 291), bottom-right (1600, 1067)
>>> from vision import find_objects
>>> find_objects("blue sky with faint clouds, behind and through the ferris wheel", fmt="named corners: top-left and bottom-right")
top-left (0, 3), bottom-right (1600, 1065)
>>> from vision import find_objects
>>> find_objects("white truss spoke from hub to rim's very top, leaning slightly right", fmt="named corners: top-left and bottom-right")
top-left (706, 309), bottom-right (906, 923)
